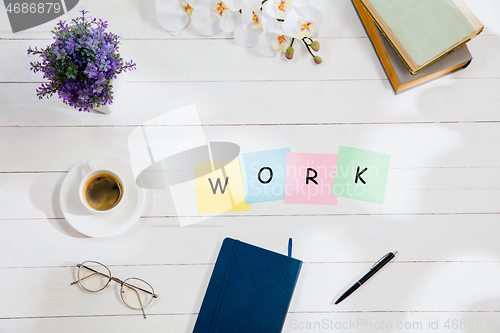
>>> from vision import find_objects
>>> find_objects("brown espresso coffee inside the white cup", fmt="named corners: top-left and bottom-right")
top-left (83, 173), bottom-right (123, 211)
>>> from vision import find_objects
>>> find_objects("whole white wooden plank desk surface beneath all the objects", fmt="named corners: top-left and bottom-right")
top-left (0, 0), bottom-right (500, 333)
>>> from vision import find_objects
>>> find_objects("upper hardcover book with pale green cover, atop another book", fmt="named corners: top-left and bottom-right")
top-left (361, 0), bottom-right (484, 74)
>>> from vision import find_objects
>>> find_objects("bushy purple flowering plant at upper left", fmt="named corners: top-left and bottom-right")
top-left (28, 10), bottom-right (136, 111)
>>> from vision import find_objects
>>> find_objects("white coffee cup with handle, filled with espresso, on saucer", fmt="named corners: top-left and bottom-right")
top-left (79, 160), bottom-right (126, 214)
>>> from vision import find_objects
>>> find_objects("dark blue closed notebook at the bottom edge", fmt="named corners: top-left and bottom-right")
top-left (193, 238), bottom-right (302, 333)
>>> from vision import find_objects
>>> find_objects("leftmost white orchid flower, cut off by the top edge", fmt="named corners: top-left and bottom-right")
top-left (156, 0), bottom-right (193, 35)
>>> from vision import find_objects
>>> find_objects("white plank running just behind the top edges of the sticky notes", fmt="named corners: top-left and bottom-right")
top-left (0, 122), bottom-right (500, 172)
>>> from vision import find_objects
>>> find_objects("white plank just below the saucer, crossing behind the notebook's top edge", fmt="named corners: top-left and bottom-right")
top-left (0, 214), bottom-right (499, 266)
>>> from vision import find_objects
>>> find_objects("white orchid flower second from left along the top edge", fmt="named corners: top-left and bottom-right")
top-left (191, 0), bottom-right (241, 36)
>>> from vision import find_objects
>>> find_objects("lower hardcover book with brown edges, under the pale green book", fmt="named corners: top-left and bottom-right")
top-left (352, 0), bottom-right (472, 93)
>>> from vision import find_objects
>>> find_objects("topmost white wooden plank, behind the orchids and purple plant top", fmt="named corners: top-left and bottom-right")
top-left (0, 0), bottom-right (500, 39)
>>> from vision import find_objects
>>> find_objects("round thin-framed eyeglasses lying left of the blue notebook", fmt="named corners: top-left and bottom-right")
top-left (71, 261), bottom-right (158, 318)
